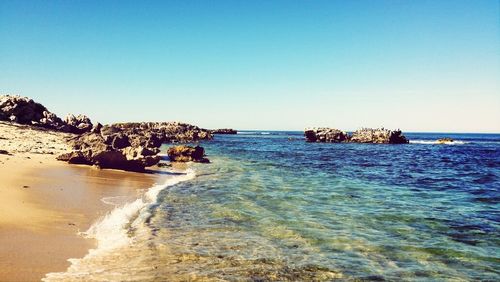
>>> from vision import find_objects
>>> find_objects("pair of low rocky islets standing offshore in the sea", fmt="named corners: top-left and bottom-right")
top-left (304, 127), bottom-right (409, 144)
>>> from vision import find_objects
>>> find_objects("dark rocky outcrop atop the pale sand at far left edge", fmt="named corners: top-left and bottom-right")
top-left (0, 95), bottom-right (92, 134)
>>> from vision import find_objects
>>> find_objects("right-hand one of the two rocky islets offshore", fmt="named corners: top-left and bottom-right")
top-left (349, 128), bottom-right (409, 144)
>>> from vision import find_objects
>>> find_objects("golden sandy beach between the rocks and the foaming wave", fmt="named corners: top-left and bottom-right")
top-left (0, 122), bottom-right (163, 281)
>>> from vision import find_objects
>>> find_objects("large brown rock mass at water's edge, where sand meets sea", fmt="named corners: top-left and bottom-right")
top-left (57, 122), bottom-right (212, 171)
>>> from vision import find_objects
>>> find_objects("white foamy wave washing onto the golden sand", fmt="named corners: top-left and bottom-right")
top-left (42, 169), bottom-right (196, 281)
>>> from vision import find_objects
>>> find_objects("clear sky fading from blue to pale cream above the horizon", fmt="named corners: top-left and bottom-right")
top-left (0, 0), bottom-right (500, 133)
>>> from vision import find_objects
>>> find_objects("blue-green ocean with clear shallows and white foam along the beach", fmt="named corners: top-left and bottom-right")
top-left (45, 131), bottom-right (500, 281)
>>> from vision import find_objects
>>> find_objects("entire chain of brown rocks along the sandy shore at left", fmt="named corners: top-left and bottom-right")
top-left (0, 95), bottom-right (212, 171)
